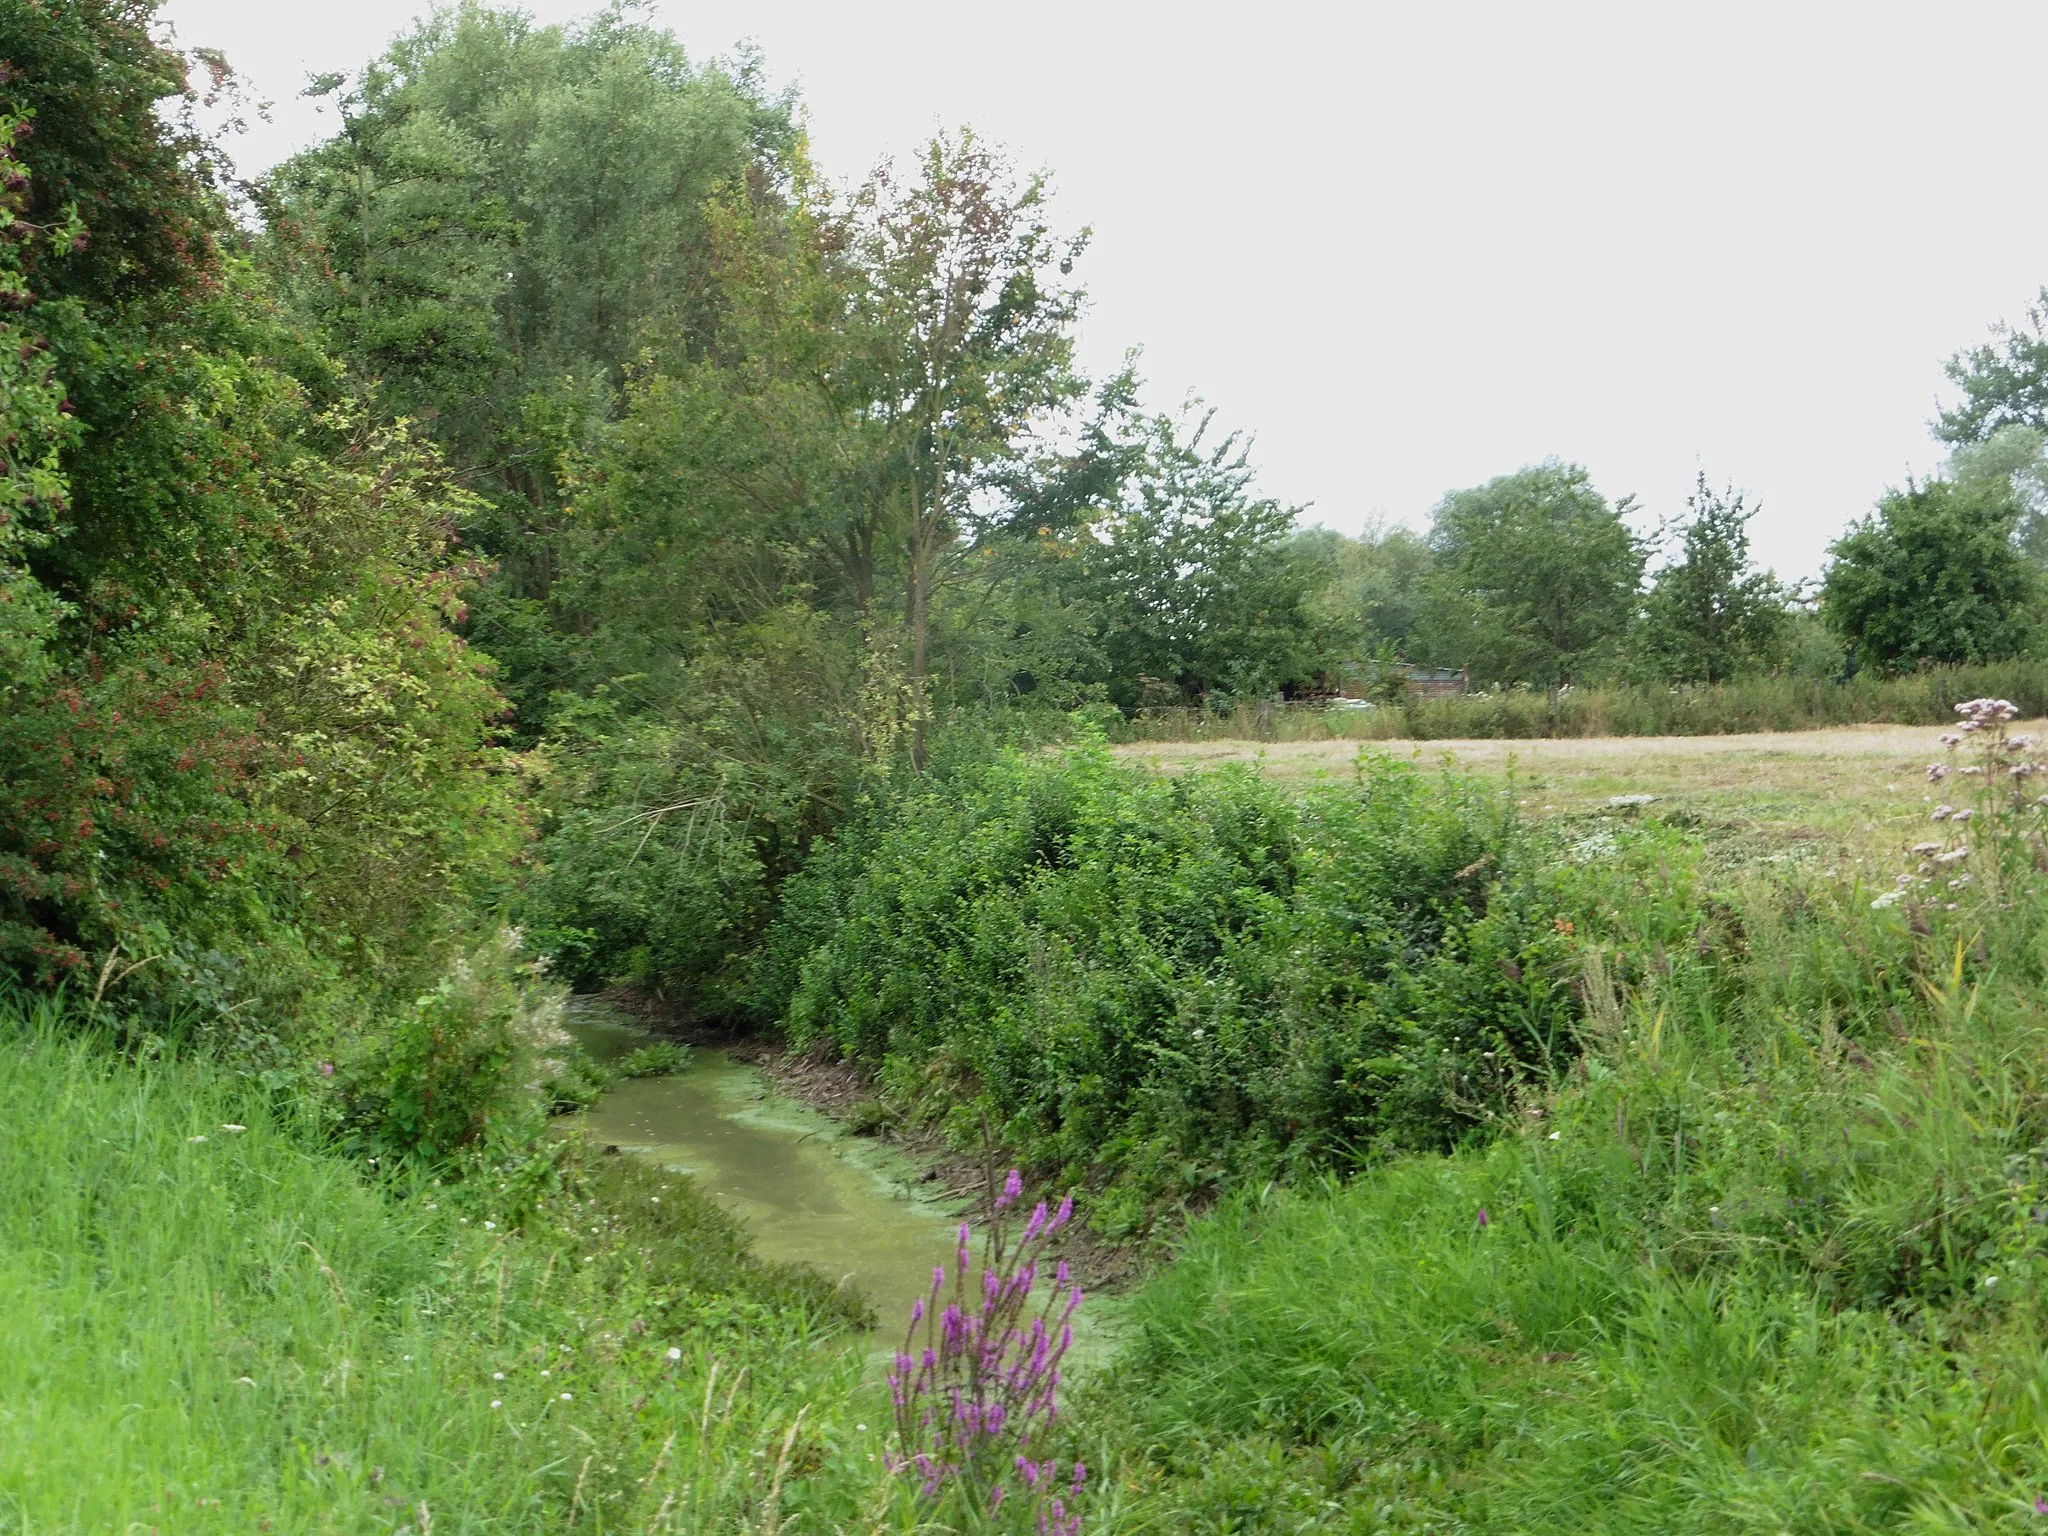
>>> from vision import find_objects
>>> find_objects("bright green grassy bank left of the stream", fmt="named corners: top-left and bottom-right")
top-left (0, 1004), bottom-right (901, 1536)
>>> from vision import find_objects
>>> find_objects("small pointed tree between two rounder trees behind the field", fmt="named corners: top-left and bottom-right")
top-left (1632, 473), bottom-right (1790, 684)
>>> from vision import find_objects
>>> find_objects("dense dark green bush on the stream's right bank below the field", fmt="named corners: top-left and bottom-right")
top-left (760, 748), bottom-right (1575, 1198)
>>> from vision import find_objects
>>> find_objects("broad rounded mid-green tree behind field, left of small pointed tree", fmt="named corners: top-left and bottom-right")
top-left (1427, 461), bottom-right (1645, 688)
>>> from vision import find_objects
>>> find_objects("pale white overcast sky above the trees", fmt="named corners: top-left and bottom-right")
top-left (164, 0), bottom-right (2048, 575)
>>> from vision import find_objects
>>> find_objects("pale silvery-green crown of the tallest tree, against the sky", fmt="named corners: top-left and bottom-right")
top-left (260, 0), bottom-right (797, 602)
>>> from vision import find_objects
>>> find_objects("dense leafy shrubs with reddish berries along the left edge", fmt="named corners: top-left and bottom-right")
top-left (0, 4), bottom-right (518, 1034)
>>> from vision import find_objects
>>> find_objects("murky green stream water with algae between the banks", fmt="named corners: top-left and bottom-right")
top-left (563, 1004), bottom-right (974, 1341)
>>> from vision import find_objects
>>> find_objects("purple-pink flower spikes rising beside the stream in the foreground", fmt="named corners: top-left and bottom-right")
top-left (889, 1169), bottom-right (1087, 1536)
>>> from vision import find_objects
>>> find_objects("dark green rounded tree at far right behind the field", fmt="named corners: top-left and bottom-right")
top-left (1821, 479), bottom-right (2040, 672)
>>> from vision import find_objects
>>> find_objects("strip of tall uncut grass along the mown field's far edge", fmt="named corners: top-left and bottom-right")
top-left (1116, 662), bottom-right (2048, 741)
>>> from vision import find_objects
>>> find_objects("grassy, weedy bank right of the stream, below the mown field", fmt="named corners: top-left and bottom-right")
top-left (1083, 729), bottom-right (2048, 1536)
